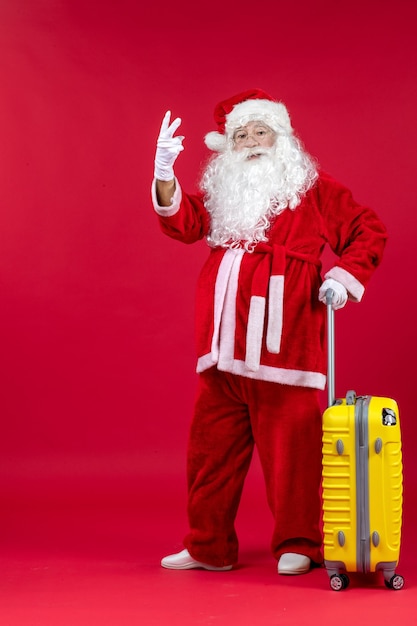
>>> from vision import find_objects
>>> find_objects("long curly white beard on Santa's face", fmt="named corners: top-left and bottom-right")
top-left (201, 135), bottom-right (317, 251)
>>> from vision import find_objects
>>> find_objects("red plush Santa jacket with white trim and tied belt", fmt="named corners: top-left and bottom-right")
top-left (152, 173), bottom-right (386, 389)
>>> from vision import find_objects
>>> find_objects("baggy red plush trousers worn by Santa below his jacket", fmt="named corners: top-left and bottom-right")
top-left (184, 368), bottom-right (322, 566)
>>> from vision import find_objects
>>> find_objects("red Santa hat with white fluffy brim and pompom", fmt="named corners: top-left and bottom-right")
top-left (204, 89), bottom-right (292, 152)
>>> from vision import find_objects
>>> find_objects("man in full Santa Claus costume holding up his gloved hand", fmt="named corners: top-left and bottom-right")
top-left (152, 89), bottom-right (386, 574)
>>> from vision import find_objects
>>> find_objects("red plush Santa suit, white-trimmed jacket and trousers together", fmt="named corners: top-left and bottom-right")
top-left (152, 91), bottom-right (386, 567)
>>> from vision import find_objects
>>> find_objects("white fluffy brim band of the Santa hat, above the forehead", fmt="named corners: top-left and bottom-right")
top-left (226, 99), bottom-right (292, 135)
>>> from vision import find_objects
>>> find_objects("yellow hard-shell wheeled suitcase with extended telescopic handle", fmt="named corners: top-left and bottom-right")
top-left (322, 294), bottom-right (404, 591)
